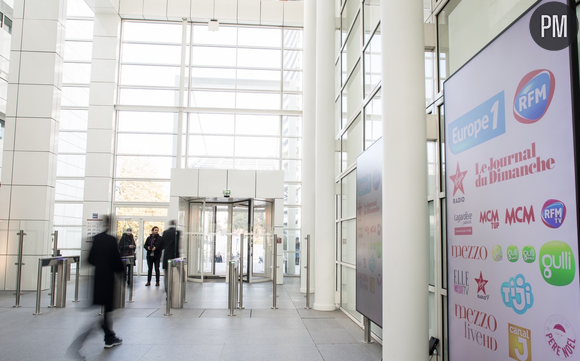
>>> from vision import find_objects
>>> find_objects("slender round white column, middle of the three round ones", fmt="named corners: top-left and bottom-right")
top-left (311, 0), bottom-right (335, 311)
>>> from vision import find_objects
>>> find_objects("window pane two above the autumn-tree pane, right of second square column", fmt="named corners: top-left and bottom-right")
top-left (117, 133), bottom-right (177, 155)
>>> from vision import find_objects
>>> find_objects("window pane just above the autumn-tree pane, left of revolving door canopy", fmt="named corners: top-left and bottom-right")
top-left (115, 156), bottom-right (175, 179)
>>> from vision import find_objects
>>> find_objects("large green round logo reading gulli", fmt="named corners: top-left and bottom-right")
top-left (539, 241), bottom-right (576, 286)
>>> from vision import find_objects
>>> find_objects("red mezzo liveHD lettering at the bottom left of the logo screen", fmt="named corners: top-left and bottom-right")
top-left (455, 303), bottom-right (497, 351)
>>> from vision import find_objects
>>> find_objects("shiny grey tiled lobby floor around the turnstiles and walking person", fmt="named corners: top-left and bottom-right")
top-left (0, 277), bottom-right (382, 361)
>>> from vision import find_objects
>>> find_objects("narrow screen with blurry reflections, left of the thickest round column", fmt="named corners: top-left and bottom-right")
top-left (356, 138), bottom-right (383, 327)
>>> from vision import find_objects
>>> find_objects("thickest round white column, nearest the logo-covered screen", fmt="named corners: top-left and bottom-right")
top-left (381, 0), bottom-right (429, 360)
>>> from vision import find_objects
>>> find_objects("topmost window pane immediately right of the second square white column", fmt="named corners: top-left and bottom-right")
top-left (123, 21), bottom-right (182, 44)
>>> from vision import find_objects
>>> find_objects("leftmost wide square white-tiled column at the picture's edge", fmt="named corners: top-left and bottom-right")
top-left (0, 0), bottom-right (66, 290)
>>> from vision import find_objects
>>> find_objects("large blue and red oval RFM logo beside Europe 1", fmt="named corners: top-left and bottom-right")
top-left (514, 69), bottom-right (556, 124)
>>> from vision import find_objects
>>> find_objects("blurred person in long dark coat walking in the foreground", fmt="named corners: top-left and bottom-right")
top-left (89, 217), bottom-right (123, 348)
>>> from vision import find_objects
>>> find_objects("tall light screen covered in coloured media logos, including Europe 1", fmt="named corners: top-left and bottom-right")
top-left (444, 1), bottom-right (580, 361)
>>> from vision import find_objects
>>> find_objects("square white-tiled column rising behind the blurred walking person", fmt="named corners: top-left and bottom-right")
top-left (82, 13), bottom-right (121, 272)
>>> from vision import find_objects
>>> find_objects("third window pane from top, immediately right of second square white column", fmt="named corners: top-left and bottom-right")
top-left (121, 65), bottom-right (180, 88)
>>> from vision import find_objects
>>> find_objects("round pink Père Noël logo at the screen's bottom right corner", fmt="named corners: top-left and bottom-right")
top-left (544, 315), bottom-right (576, 360)
